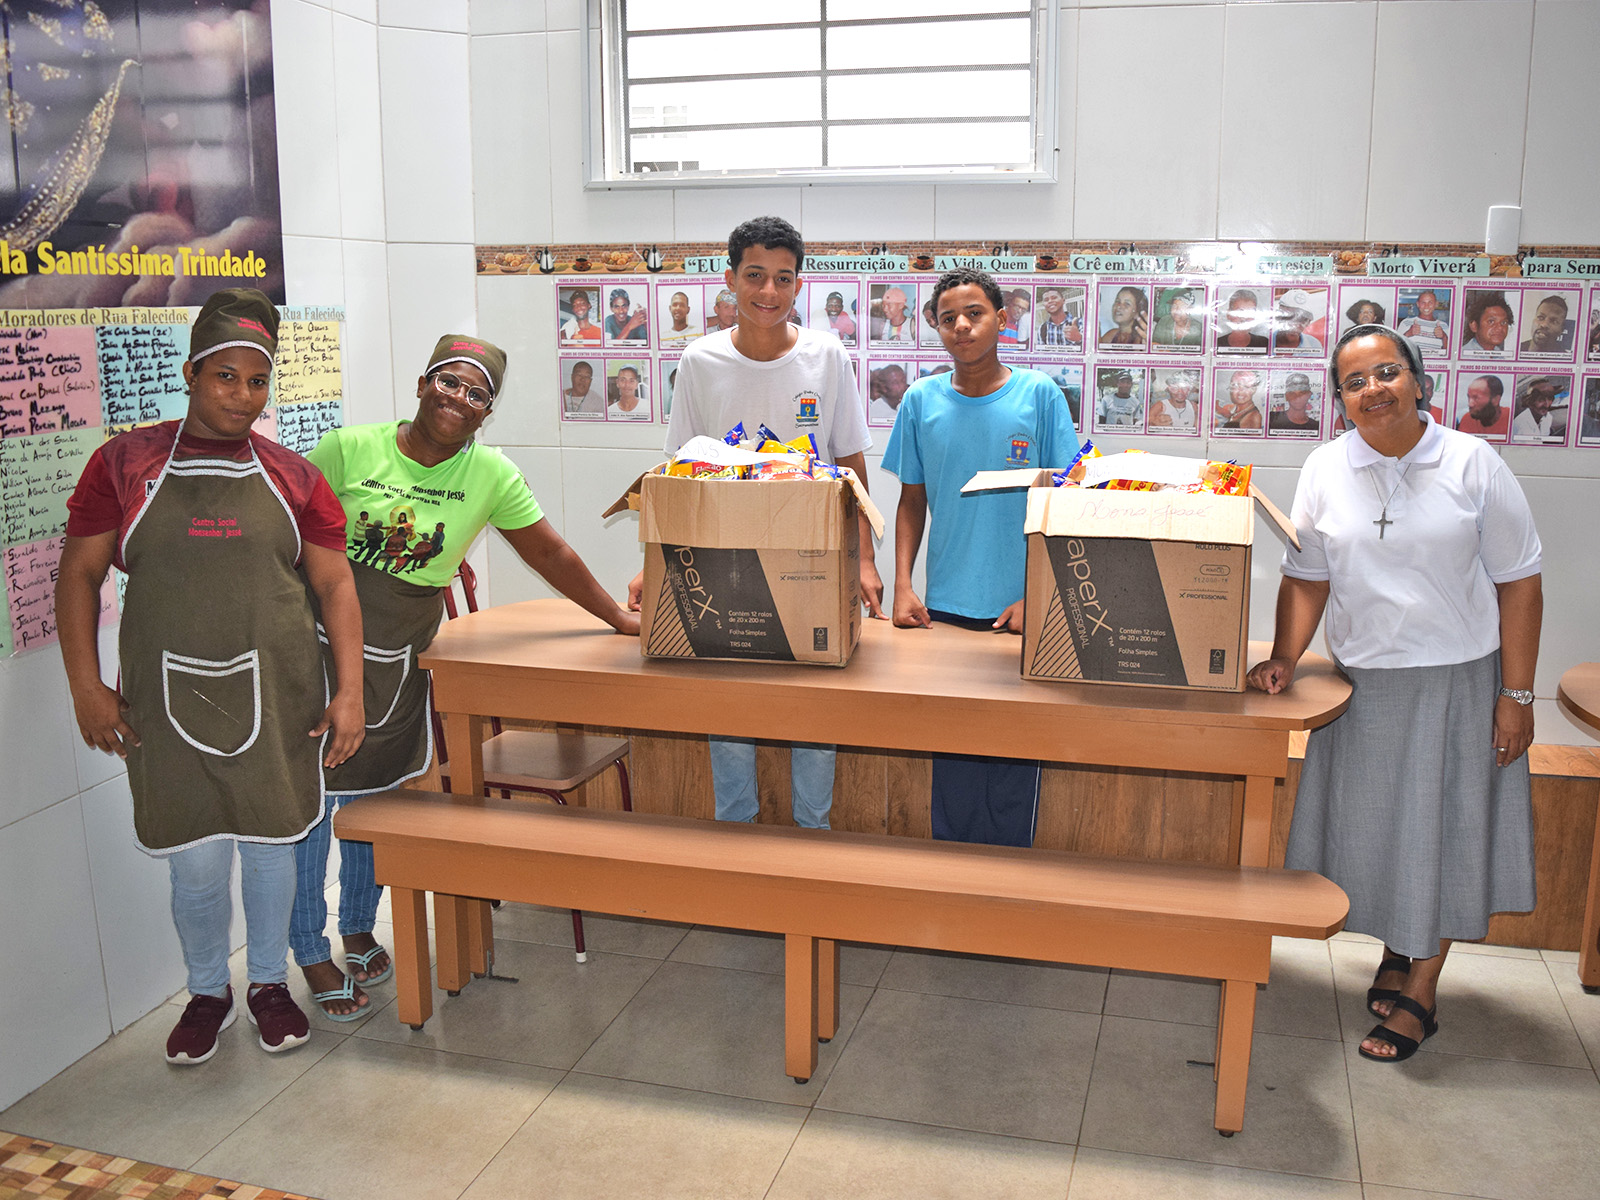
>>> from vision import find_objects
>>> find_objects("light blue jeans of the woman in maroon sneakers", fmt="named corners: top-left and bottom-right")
top-left (166, 838), bottom-right (294, 995)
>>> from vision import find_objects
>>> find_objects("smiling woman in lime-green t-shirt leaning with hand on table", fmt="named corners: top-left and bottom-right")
top-left (290, 334), bottom-right (638, 1021)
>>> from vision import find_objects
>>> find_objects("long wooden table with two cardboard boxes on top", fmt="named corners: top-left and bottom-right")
top-left (421, 600), bottom-right (1350, 992)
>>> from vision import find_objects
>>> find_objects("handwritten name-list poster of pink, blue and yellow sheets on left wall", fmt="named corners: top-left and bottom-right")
top-left (0, 307), bottom-right (344, 658)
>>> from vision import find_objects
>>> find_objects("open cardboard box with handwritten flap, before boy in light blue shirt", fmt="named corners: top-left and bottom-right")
top-left (965, 456), bottom-right (1294, 691)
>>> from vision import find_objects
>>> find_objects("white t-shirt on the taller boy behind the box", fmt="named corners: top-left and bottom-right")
top-left (667, 326), bottom-right (872, 462)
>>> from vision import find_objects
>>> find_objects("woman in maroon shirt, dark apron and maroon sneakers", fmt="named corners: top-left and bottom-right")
top-left (56, 288), bottom-right (363, 1066)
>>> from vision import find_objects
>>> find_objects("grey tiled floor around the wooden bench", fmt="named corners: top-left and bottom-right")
top-left (0, 906), bottom-right (1600, 1200)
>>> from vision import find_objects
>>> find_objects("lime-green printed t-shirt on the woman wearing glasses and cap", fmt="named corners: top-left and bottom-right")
top-left (306, 421), bottom-right (544, 587)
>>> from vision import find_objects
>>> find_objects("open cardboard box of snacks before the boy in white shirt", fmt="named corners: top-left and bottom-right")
top-left (605, 474), bottom-right (882, 667)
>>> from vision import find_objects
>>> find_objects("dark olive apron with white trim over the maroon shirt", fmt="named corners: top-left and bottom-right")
top-left (120, 442), bottom-right (326, 853)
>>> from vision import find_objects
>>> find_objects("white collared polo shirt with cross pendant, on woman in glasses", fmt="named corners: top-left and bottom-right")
top-left (1283, 413), bottom-right (1541, 667)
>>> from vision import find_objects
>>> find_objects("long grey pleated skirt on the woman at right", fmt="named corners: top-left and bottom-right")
top-left (1285, 651), bottom-right (1533, 958)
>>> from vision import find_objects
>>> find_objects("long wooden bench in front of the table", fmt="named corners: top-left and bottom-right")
top-left (334, 792), bottom-right (1349, 1134)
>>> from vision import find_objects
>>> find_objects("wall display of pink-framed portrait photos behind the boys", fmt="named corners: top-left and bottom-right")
top-left (554, 272), bottom-right (1600, 446)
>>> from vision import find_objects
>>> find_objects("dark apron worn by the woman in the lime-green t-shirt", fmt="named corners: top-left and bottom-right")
top-left (314, 562), bottom-right (445, 795)
